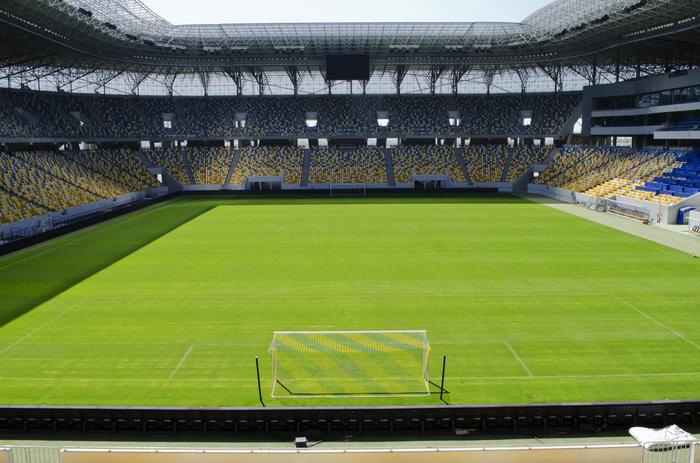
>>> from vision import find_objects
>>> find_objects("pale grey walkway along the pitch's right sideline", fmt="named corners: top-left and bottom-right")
top-left (521, 194), bottom-right (700, 260)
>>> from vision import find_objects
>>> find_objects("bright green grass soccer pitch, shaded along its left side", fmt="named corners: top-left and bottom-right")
top-left (0, 197), bottom-right (700, 406)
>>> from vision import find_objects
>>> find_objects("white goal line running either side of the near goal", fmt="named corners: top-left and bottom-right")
top-left (0, 371), bottom-right (700, 383)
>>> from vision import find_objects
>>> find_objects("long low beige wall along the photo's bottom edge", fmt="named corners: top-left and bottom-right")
top-left (62, 444), bottom-right (700, 463)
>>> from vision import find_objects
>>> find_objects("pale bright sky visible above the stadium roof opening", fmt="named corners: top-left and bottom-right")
top-left (143, 0), bottom-right (552, 24)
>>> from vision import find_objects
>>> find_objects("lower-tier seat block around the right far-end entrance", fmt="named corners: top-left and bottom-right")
top-left (392, 145), bottom-right (466, 183)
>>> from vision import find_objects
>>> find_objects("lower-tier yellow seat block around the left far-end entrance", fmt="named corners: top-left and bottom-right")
top-left (231, 146), bottom-right (302, 185)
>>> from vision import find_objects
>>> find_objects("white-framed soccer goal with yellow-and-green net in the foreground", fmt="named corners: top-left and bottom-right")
top-left (270, 331), bottom-right (430, 398)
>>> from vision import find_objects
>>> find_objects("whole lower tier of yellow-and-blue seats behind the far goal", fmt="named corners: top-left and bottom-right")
top-left (149, 145), bottom-right (551, 185)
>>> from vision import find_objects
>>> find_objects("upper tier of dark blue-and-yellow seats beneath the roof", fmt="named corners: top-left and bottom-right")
top-left (0, 90), bottom-right (580, 140)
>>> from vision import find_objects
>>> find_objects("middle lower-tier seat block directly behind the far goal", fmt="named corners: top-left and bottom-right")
top-left (309, 146), bottom-right (387, 183)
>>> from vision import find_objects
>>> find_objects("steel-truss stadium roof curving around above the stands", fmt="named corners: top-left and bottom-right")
top-left (0, 0), bottom-right (700, 95)
